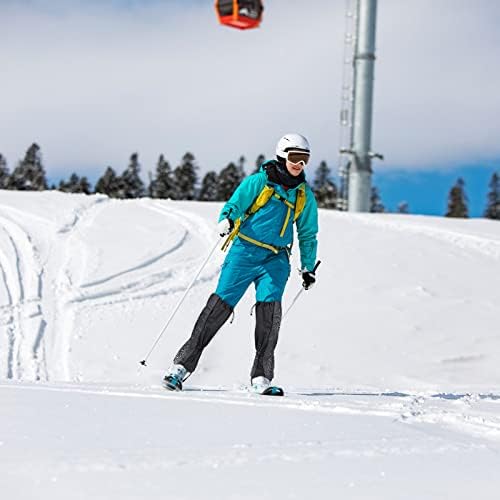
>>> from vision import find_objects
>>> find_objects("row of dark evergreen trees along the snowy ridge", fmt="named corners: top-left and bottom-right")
top-left (0, 144), bottom-right (500, 220)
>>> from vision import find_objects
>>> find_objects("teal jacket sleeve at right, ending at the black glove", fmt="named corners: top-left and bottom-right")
top-left (296, 186), bottom-right (318, 271)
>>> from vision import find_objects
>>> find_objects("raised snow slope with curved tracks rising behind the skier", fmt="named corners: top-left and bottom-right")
top-left (0, 191), bottom-right (500, 393)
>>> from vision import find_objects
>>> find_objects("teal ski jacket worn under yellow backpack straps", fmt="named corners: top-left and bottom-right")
top-left (219, 160), bottom-right (318, 271)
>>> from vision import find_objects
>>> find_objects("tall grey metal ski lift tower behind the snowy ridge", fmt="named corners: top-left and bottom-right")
top-left (340, 0), bottom-right (383, 212)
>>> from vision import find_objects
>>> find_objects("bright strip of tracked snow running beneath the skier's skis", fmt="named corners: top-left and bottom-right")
top-left (5, 383), bottom-right (500, 443)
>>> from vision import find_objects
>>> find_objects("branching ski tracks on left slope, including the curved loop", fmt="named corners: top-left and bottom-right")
top-left (0, 198), bottom-right (219, 380)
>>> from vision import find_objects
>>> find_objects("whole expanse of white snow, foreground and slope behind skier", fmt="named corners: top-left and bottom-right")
top-left (0, 191), bottom-right (500, 500)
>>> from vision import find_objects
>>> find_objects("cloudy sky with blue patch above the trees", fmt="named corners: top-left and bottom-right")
top-left (0, 0), bottom-right (500, 215)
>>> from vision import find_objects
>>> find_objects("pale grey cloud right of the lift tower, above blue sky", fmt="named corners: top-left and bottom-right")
top-left (374, 0), bottom-right (500, 166)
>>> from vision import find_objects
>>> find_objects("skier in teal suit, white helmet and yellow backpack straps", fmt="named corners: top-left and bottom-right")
top-left (163, 133), bottom-right (318, 395)
